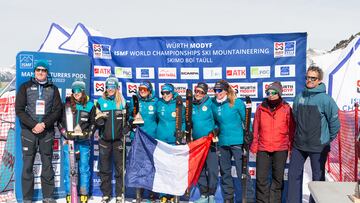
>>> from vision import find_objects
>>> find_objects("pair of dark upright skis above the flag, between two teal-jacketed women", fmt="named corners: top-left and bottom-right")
top-left (175, 89), bottom-right (193, 145)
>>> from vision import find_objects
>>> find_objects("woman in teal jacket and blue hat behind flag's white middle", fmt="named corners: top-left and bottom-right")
top-left (156, 84), bottom-right (185, 203)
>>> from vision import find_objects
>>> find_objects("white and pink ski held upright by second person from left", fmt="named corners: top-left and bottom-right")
top-left (65, 98), bottom-right (78, 203)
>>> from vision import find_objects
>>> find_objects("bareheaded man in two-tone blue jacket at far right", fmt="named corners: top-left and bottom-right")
top-left (287, 65), bottom-right (340, 203)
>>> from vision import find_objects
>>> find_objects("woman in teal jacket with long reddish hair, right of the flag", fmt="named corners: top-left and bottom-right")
top-left (212, 80), bottom-right (245, 203)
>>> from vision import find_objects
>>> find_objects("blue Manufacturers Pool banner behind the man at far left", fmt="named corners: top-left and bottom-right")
top-left (15, 52), bottom-right (91, 202)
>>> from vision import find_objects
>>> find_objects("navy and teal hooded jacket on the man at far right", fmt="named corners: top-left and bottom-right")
top-left (293, 83), bottom-right (340, 152)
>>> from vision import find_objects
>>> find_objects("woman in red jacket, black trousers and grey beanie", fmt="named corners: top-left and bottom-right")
top-left (250, 82), bottom-right (295, 203)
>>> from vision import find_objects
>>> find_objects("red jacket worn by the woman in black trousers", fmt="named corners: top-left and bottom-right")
top-left (250, 100), bottom-right (295, 153)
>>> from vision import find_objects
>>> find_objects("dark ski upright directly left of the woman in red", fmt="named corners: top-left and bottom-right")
top-left (241, 96), bottom-right (252, 203)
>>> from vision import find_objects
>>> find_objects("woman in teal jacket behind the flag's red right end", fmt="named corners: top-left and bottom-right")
top-left (192, 82), bottom-right (219, 203)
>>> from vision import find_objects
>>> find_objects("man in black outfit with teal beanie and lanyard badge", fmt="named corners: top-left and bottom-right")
top-left (15, 61), bottom-right (62, 203)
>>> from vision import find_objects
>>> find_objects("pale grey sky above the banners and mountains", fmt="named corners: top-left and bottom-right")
top-left (0, 0), bottom-right (360, 67)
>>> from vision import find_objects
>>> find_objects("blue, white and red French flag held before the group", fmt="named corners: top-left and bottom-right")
top-left (126, 128), bottom-right (213, 196)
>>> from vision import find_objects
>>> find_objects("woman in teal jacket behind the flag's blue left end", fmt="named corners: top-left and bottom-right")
top-left (129, 81), bottom-right (158, 203)
